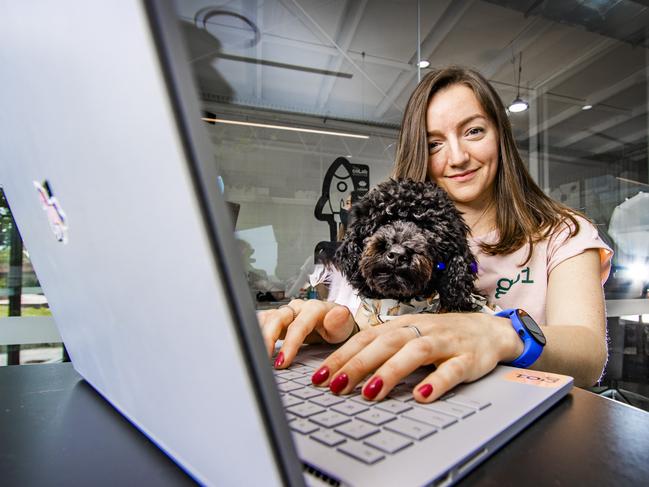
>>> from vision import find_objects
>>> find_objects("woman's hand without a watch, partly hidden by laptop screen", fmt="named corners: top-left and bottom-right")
top-left (257, 299), bottom-right (355, 368)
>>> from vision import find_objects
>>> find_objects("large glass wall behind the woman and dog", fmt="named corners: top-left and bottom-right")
top-left (179, 0), bottom-right (649, 400)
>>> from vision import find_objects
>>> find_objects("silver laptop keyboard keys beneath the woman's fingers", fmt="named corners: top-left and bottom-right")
top-left (274, 356), bottom-right (491, 465)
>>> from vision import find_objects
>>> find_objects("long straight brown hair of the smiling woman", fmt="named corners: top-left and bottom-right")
top-left (393, 66), bottom-right (586, 264)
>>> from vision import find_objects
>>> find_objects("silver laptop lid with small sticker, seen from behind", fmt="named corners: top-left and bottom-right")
top-left (0, 0), bottom-right (302, 485)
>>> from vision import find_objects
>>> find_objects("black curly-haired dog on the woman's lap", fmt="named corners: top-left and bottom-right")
top-left (334, 179), bottom-right (477, 311)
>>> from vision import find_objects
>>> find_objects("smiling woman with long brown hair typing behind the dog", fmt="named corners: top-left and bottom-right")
top-left (260, 67), bottom-right (611, 402)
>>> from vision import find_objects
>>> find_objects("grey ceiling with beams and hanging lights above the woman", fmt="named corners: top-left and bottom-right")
top-left (178, 0), bottom-right (649, 174)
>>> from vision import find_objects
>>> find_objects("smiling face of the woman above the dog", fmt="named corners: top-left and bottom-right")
top-left (426, 84), bottom-right (499, 208)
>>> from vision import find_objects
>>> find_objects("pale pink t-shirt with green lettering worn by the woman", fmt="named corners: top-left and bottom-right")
top-left (469, 217), bottom-right (613, 325)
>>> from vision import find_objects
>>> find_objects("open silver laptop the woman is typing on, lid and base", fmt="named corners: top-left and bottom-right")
top-left (0, 0), bottom-right (572, 486)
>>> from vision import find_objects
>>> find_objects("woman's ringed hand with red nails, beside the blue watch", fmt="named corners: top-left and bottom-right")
top-left (312, 313), bottom-right (523, 402)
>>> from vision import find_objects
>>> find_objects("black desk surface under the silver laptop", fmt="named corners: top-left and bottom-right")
top-left (0, 364), bottom-right (649, 486)
